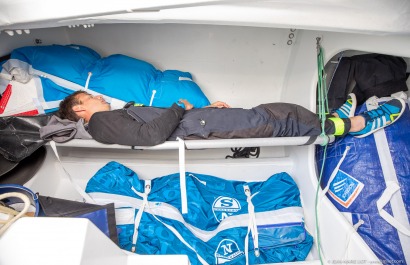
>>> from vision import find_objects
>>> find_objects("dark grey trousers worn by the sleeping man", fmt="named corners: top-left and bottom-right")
top-left (168, 103), bottom-right (335, 140)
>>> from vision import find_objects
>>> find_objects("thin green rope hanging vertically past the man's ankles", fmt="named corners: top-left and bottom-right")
top-left (315, 38), bottom-right (329, 265)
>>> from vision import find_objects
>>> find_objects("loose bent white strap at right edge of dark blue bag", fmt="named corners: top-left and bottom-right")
top-left (376, 181), bottom-right (410, 236)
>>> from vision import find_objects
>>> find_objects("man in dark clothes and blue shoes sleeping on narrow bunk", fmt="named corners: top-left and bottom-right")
top-left (59, 91), bottom-right (405, 146)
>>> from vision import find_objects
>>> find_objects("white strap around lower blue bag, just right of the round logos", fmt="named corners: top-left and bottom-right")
top-left (243, 185), bottom-right (260, 265)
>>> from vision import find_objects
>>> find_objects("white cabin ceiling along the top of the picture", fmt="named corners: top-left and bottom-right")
top-left (0, 0), bottom-right (410, 35)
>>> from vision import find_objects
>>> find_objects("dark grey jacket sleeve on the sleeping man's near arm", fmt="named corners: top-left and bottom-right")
top-left (88, 104), bottom-right (184, 146)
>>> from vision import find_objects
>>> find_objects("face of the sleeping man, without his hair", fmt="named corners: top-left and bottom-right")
top-left (74, 93), bottom-right (110, 120)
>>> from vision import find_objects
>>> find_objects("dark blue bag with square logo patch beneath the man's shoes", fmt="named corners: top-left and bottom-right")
top-left (316, 98), bottom-right (410, 264)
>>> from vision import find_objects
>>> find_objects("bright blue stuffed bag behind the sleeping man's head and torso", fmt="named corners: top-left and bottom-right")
top-left (5, 45), bottom-right (210, 111)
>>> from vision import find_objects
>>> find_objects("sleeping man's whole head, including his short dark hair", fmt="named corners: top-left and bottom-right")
top-left (59, 90), bottom-right (110, 122)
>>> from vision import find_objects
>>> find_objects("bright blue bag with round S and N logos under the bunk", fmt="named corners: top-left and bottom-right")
top-left (86, 162), bottom-right (313, 264)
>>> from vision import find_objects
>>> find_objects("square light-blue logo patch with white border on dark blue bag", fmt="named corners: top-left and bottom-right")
top-left (329, 170), bottom-right (364, 208)
